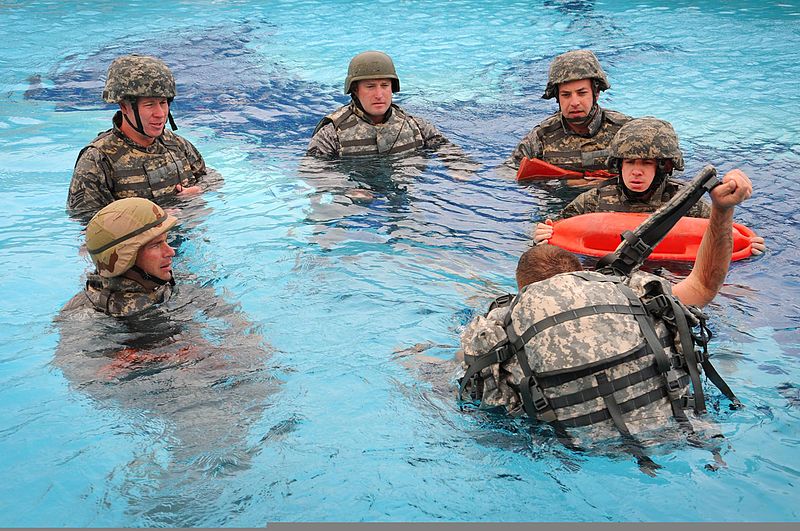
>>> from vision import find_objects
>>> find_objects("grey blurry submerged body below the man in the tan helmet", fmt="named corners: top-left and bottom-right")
top-left (53, 282), bottom-right (279, 526)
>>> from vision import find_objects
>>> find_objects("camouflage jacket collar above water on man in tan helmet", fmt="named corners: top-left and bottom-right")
top-left (61, 274), bottom-right (173, 317)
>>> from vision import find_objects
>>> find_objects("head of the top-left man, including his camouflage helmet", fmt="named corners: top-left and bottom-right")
top-left (103, 54), bottom-right (177, 145)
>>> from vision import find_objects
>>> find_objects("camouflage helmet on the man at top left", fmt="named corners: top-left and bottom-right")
top-left (103, 54), bottom-right (176, 103)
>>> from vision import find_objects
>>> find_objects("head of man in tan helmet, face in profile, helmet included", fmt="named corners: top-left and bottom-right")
top-left (86, 197), bottom-right (178, 284)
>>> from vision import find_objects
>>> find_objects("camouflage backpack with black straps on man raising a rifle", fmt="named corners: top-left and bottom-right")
top-left (460, 271), bottom-right (738, 436)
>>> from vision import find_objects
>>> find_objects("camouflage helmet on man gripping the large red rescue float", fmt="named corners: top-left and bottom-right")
top-left (607, 116), bottom-right (683, 173)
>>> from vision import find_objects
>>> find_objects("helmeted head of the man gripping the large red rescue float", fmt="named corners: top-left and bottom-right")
top-left (607, 116), bottom-right (683, 201)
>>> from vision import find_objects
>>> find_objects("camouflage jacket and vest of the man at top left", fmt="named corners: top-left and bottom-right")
top-left (67, 112), bottom-right (207, 220)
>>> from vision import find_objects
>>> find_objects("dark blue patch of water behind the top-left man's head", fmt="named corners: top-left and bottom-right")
top-left (24, 20), bottom-right (341, 155)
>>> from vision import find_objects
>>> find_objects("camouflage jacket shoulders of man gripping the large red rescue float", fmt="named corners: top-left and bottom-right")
top-left (556, 179), bottom-right (711, 219)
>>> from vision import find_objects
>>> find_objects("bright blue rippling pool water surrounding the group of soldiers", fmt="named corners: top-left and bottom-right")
top-left (0, 0), bottom-right (800, 526)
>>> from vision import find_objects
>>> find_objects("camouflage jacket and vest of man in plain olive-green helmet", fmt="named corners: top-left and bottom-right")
top-left (306, 102), bottom-right (449, 159)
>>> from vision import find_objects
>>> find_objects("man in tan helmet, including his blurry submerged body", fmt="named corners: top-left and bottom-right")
top-left (53, 198), bottom-right (277, 474)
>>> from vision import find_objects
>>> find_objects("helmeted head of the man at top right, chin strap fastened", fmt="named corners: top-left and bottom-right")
top-left (542, 50), bottom-right (611, 124)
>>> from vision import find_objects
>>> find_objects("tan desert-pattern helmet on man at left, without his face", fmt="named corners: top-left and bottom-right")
top-left (86, 197), bottom-right (178, 277)
